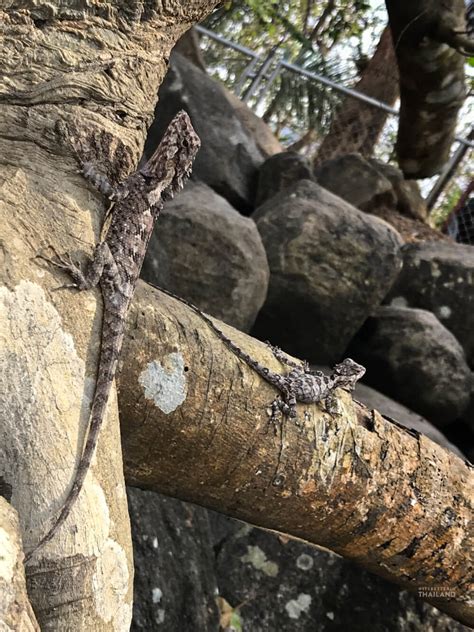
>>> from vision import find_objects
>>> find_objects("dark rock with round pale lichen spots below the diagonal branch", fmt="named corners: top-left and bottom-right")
top-left (210, 513), bottom-right (467, 632)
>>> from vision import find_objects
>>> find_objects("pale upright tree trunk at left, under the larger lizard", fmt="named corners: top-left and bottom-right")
top-left (0, 0), bottom-right (217, 631)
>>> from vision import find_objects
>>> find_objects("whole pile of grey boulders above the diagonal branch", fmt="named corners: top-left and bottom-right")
top-left (144, 50), bottom-right (474, 449)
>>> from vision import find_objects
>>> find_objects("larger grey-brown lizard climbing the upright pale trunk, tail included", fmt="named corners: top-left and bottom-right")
top-left (25, 111), bottom-right (201, 561)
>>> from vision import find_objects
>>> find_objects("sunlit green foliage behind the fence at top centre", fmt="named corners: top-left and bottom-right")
top-left (204, 0), bottom-right (385, 142)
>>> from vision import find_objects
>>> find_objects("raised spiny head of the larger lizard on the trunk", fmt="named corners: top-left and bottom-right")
top-left (139, 110), bottom-right (201, 205)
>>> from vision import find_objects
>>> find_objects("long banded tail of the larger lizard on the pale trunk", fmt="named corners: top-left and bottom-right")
top-left (25, 322), bottom-right (123, 563)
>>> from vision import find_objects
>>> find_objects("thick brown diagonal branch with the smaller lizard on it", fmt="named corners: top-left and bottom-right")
top-left (119, 283), bottom-right (474, 624)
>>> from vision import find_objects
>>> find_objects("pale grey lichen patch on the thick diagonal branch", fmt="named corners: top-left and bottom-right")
top-left (138, 353), bottom-right (188, 414)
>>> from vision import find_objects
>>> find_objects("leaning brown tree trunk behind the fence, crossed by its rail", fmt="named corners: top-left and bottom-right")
top-left (314, 26), bottom-right (398, 165)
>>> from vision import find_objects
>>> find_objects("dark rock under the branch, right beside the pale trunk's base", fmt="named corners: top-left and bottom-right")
top-left (127, 487), bottom-right (219, 632)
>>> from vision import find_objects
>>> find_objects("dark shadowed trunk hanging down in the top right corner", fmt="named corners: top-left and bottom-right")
top-left (386, 0), bottom-right (474, 178)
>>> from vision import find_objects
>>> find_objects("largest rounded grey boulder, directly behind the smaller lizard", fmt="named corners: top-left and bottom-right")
top-left (254, 180), bottom-right (402, 363)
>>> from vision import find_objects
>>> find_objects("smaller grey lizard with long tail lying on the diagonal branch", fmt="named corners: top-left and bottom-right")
top-left (157, 287), bottom-right (365, 421)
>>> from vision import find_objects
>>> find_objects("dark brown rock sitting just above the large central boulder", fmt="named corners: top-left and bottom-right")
top-left (314, 154), bottom-right (397, 213)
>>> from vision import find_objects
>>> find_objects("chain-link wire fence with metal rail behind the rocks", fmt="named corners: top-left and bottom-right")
top-left (197, 26), bottom-right (474, 243)
